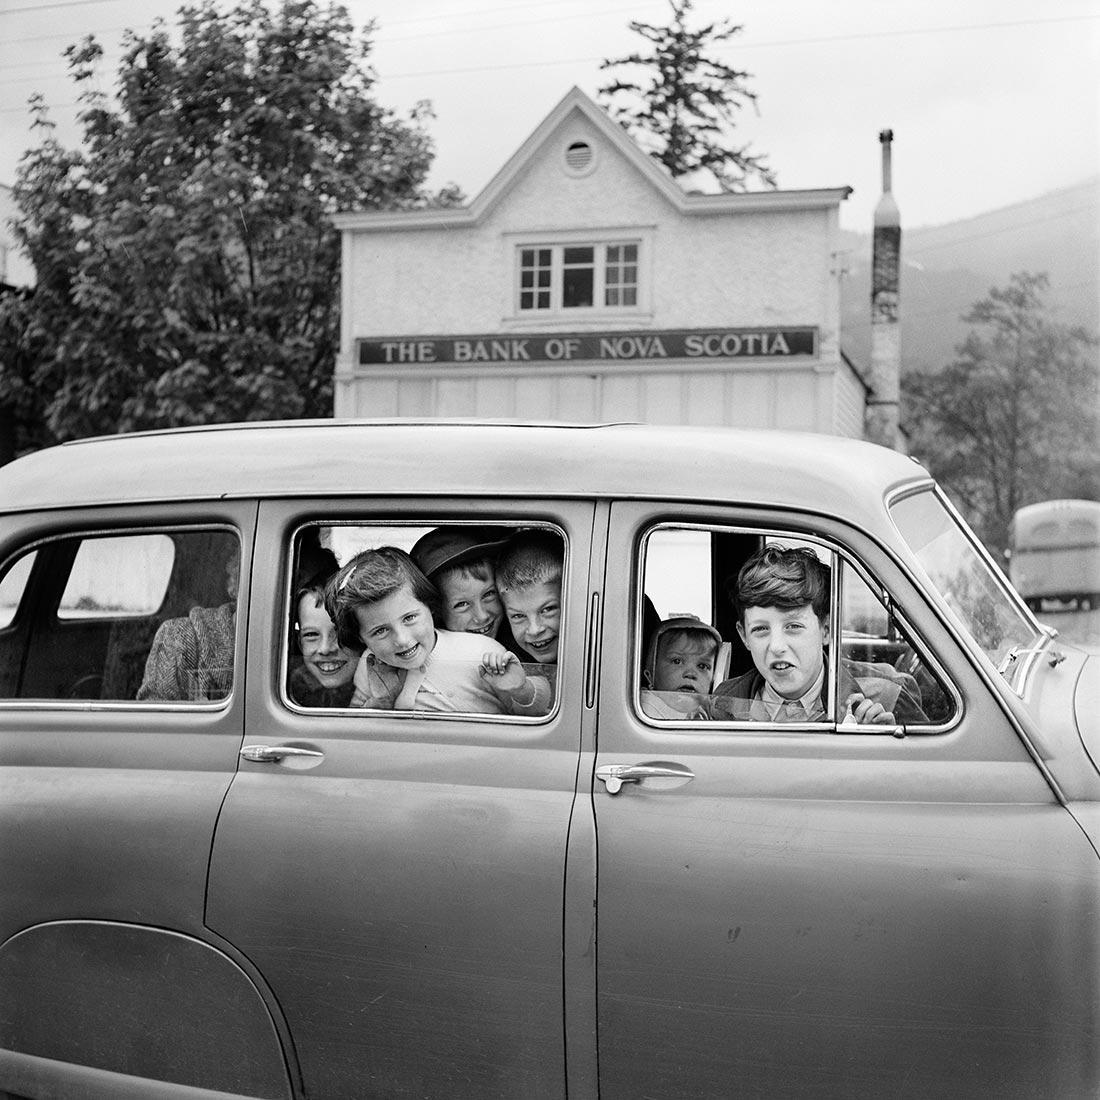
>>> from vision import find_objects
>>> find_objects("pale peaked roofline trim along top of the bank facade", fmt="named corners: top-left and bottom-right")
top-left (332, 87), bottom-right (851, 230)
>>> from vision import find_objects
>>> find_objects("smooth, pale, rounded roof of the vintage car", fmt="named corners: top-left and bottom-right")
top-left (0, 419), bottom-right (928, 518)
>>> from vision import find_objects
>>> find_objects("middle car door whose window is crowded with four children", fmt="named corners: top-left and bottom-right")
top-left (207, 497), bottom-right (594, 1100)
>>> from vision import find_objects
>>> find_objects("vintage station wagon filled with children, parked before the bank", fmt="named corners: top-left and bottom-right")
top-left (0, 421), bottom-right (1100, 1100)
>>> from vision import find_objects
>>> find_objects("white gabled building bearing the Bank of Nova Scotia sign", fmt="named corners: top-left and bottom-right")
top-left (334, 88), bottom-right (867, 436)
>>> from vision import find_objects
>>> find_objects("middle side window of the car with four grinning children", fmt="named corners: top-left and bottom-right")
top-left (285, 520), bottom-right (568, 718)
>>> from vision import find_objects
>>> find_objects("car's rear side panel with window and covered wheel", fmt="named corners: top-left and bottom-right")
top-left (0, 501), bottom-right (289, 1097)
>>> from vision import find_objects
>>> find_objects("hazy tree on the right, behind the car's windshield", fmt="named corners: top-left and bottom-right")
top-left (902, 272), bottom-right (1100, 554)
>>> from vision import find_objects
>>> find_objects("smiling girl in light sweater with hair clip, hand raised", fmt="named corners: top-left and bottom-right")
top-left (326, 547), bottom-right (550, 715)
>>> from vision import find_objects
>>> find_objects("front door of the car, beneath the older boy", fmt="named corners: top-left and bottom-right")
top-left (592, 502), bottom-right (1098, 1100)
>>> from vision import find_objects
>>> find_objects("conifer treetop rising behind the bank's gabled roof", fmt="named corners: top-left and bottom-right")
top-left (600, 0), bottom-right (776, 191)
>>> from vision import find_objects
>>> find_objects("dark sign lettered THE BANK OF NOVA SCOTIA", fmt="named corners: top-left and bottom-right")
top-left (358, 326), bottom-right (817, 366)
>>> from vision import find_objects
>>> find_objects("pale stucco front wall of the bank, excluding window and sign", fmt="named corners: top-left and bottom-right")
top-left (336, 96), bottom-right (862, 435)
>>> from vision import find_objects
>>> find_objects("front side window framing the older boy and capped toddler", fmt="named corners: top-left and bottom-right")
top-left (637, 526), bottom-right (957, 733)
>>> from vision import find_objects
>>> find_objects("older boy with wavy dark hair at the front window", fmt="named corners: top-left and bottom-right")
top-left (708, 546), bottom-right (928, 726)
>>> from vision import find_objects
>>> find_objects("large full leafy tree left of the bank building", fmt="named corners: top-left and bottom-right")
top-left (0, 0), bottom-right (460, 455)
